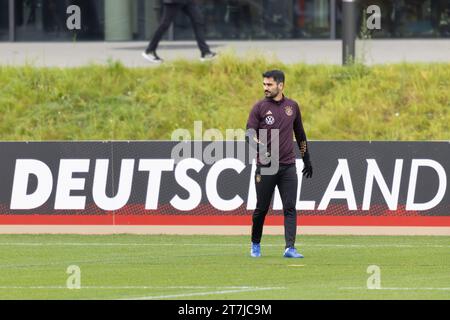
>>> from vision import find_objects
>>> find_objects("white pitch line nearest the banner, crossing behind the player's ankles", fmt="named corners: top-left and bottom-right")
top-left (0, 242), bottom-right (450, 249)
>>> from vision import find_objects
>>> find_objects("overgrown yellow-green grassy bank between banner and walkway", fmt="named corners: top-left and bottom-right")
top-left (0, 54), bottom-right (450, 140)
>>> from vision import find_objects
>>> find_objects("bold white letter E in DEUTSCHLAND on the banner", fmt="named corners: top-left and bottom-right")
top-left (55, 159), bottom-right (90, 210)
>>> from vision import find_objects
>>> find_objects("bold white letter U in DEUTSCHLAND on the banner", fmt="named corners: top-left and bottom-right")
top-left (92, 159), bottom-right (134, 211)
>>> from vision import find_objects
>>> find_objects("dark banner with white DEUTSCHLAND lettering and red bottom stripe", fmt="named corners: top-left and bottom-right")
top-left (0, 141), bottom-right (450, 232)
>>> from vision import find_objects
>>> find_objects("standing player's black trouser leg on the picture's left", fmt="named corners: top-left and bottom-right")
top-left (252, 167), bottom-right (277, 243)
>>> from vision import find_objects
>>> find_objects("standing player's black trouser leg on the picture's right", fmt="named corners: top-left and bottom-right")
top-left (278, 165), bottom-right (298, 248)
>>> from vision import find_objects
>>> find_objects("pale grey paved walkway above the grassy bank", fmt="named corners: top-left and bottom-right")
top-left (0, 39), bottom-right (450, 67)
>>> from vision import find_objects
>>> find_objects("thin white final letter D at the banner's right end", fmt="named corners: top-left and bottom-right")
top-left (406, 159), bottom-right (447, 210)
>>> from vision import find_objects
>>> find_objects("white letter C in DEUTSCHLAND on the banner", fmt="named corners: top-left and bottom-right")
top-left (205, 158), bottom-right (245, 211)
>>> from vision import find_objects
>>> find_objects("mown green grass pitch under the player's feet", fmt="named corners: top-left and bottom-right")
top-left (0, 235), bottom-right (450, 300)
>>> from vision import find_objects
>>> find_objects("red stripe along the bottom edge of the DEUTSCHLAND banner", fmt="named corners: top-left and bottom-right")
top-left (0, 214), bottom-right (450, 227)
